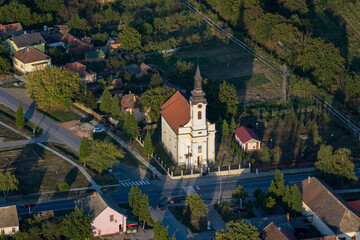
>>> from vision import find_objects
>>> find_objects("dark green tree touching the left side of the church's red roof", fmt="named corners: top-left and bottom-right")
top-left (140, 86), bottom-right (175, 122)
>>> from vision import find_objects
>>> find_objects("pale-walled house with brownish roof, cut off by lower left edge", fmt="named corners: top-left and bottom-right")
top-left (0, 205), bottom-right (19, 235)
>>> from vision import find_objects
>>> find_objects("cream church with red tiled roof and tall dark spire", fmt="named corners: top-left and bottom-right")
top-left (160, 66), bottom-right (216, 168)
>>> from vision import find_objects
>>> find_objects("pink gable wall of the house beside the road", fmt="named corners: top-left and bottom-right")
top-left (91, 207), bottom-right (126, 236)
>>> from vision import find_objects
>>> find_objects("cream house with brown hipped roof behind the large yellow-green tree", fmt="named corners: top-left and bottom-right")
top-left (13, 48), bottom-right (51, 74)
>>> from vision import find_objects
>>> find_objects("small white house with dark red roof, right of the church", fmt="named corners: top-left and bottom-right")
top-left (234, 126), bottom-right (261, 151)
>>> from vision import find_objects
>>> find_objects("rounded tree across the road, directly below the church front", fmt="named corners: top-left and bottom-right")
top-left (185, 193), bottom-right (207, 229)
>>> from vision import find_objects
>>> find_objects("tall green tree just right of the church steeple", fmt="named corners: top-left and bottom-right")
top-left (219, 81), bottom-right (239, 116)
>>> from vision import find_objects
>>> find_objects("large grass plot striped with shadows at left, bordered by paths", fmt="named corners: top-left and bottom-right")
top-left (0, 145), bottom-right (90, 195)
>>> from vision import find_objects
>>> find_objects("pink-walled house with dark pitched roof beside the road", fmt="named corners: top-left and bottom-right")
top-left (75, 192), bottom-right (126, 236)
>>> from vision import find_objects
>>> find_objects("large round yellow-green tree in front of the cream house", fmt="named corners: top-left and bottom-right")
top-left (26, 66), bottom-right (81, 107)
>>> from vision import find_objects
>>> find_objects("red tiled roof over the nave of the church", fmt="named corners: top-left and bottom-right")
top-left (160, 91), bottom-right (190, 134)
